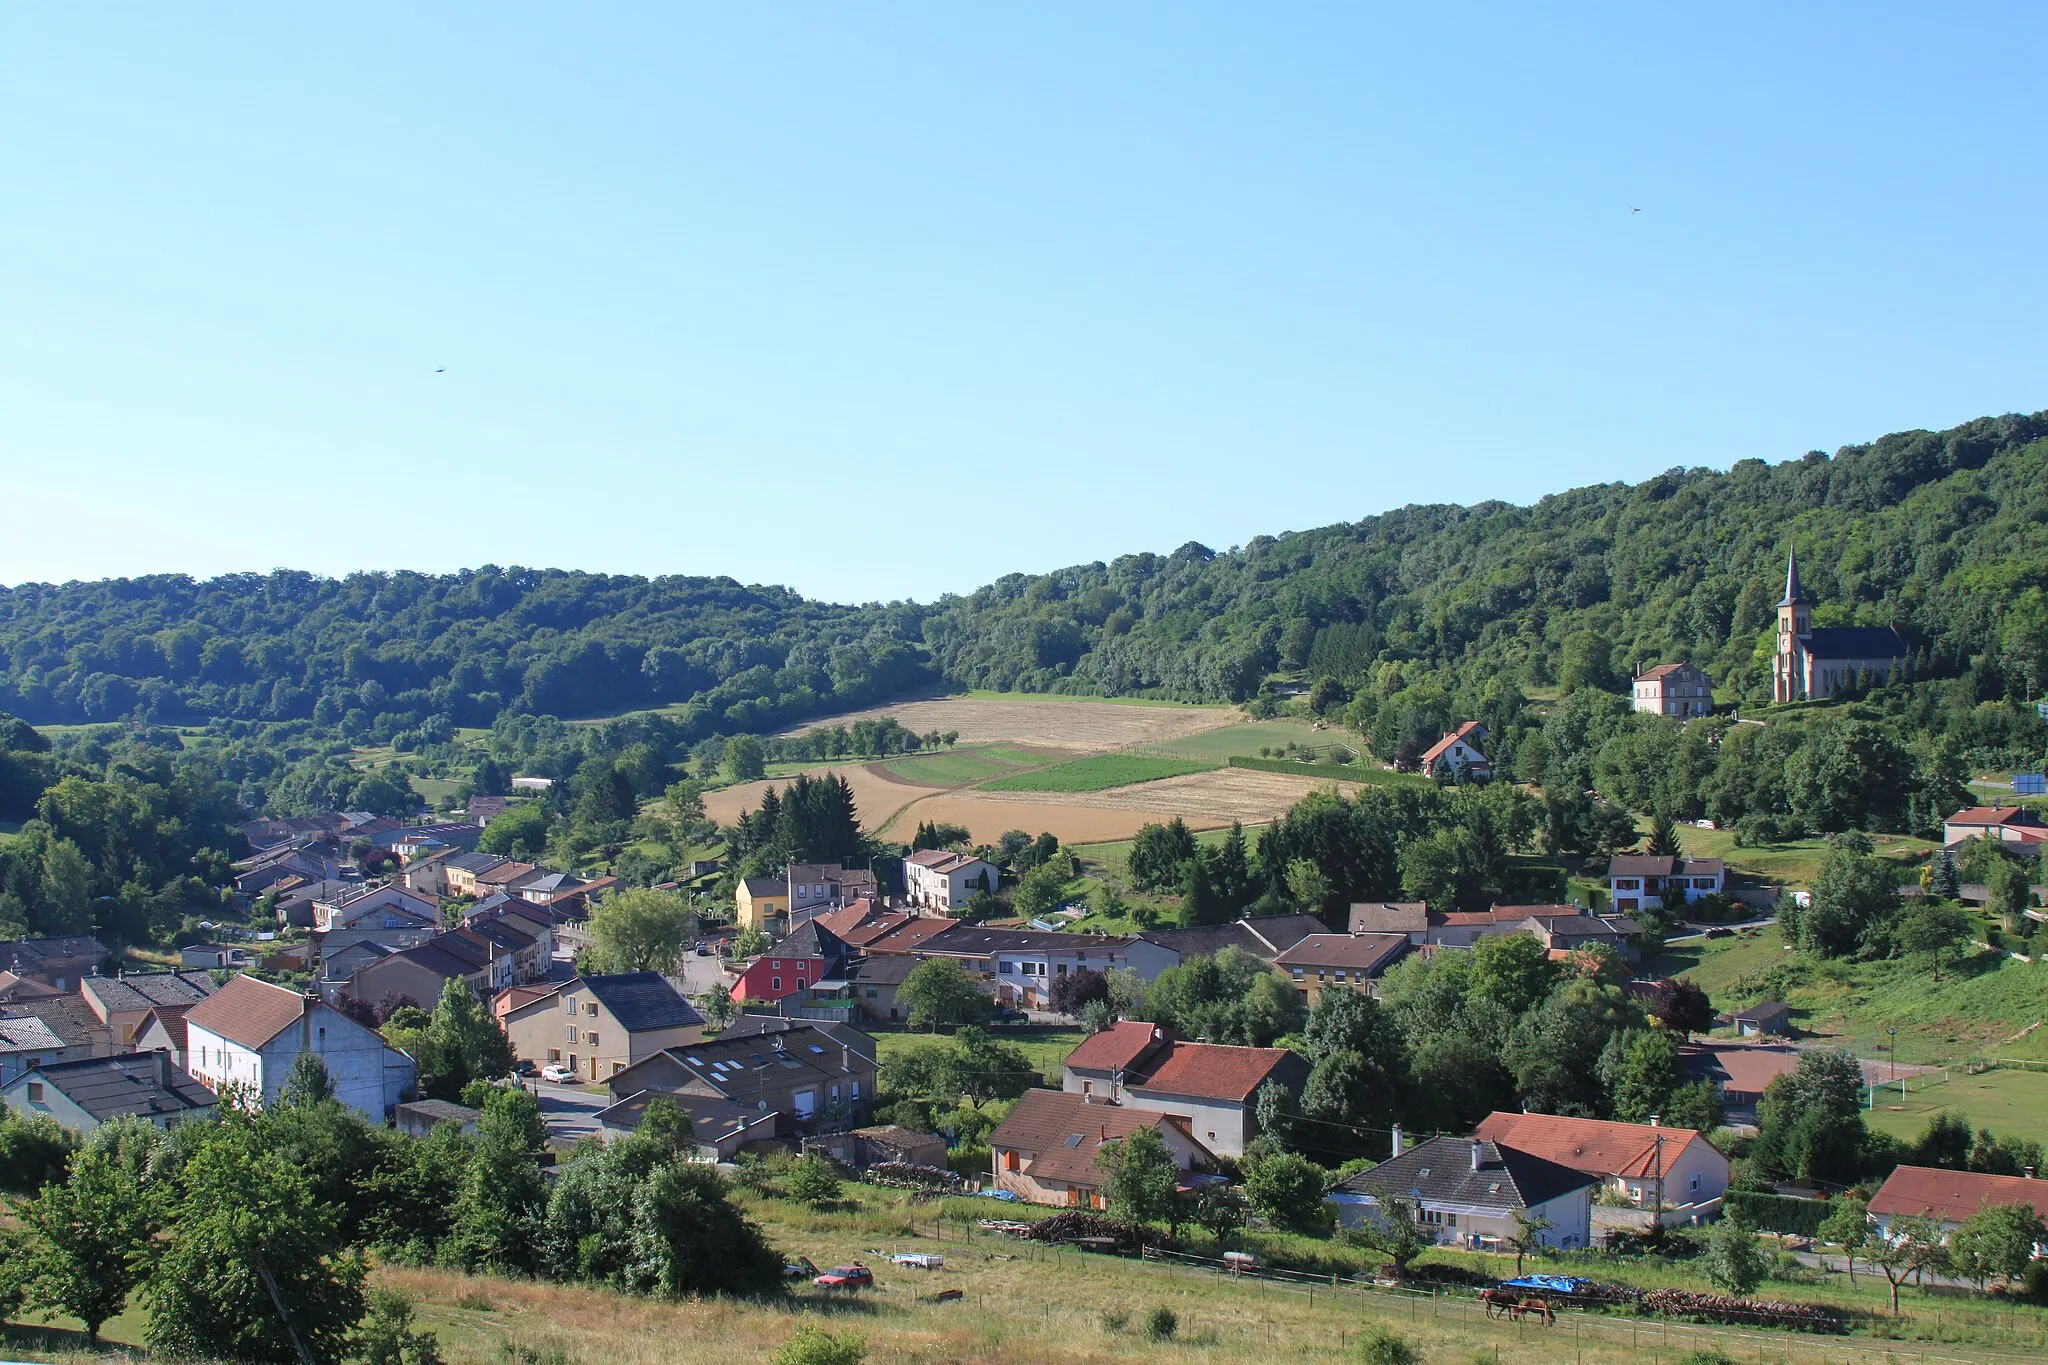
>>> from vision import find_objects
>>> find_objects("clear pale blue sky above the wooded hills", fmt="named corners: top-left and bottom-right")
top-left (0, 2), bottom-right (2048, 600)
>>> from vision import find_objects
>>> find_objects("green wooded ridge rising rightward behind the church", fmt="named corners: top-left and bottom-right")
top-left (924, 413), bottom-right (2048, 700)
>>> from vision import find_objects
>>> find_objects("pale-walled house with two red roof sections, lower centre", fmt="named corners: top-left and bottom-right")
top-left (1061, 1019), bottom-right (1309, 1156)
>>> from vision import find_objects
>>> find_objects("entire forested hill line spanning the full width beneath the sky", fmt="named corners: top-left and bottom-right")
top-left (0, 413), bottom-right (2048, 739)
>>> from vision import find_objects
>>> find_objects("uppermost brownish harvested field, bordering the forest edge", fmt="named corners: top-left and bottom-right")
top-left (788, 698), bottom-right (1243, 753)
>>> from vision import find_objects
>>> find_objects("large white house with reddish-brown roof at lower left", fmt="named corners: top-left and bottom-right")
top-left (184, 976), bottom-right (414, 1119)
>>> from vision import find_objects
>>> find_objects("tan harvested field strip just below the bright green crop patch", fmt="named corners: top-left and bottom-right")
top-left (872, 767), bottom-right (1358, 843)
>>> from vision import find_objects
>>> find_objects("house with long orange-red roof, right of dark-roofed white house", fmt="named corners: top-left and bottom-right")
top-left (1473, 1111), bottom-right (1729, 1207)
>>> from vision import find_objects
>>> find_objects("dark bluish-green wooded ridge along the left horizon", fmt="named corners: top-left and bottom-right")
top-left (0, 565), bottom-right (926, 741)
